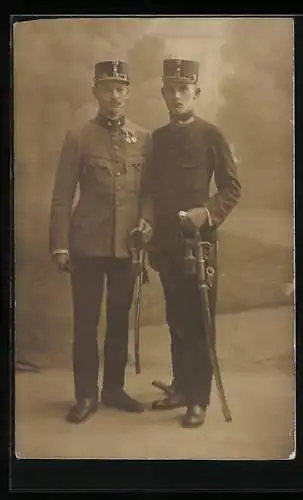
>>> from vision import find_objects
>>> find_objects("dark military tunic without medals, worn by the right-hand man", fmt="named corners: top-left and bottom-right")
top-left (152, 117), bottom-right (241, 250)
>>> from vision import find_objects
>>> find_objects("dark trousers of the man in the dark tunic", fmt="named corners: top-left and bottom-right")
top-left (158, 244), bottom-right (217, 407)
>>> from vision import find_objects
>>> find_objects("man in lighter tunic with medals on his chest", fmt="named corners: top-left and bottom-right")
top-left (50, 61), bottom-right (152, 422)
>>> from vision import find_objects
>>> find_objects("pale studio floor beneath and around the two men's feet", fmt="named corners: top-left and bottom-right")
top-left (15, 307), bottom-right (295, 460)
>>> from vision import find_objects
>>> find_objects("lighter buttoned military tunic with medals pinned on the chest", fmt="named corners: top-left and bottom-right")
top-left (50, 117), bottom-right (151, 258)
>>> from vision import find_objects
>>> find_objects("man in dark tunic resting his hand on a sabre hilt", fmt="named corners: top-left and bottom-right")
top-left (149, 59), bottom-right (241, 427)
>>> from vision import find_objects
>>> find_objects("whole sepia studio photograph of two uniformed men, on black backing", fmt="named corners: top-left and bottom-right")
top-left (11, 16), bottom-right (296, 461)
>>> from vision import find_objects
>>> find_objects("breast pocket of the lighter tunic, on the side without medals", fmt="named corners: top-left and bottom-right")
top-left (84, 157), bottom-right (114, 193)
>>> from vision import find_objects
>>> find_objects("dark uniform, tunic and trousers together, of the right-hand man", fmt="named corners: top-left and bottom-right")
top-left (152, 117), bottom-right (241, 407)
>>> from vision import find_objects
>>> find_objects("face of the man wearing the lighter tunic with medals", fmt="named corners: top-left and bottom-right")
top-left (93, 80), bottom-right (129, 118)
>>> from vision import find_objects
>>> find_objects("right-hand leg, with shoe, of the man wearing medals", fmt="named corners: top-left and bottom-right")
top-left (102, 258), bottom-right (143, 412)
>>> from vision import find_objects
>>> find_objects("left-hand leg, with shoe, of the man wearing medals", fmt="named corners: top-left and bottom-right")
top-left (67, 257), bottom-right (104, 422)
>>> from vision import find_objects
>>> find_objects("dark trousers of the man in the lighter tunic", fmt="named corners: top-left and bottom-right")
top-left (71, 257), bottom-right (134, 401)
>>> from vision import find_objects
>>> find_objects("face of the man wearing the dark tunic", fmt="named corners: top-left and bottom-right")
top-left (162, 81), bottom-right (200, 115)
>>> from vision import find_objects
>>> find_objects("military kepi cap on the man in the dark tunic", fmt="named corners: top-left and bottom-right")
top-left (163, 59), bottom-right (199, 83)
